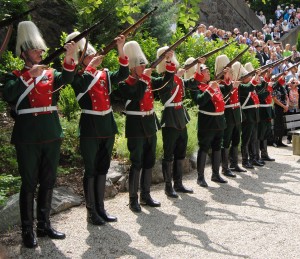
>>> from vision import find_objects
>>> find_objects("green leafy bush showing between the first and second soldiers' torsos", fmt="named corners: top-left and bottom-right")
top-left (58, 85), bottom-right (80, 121)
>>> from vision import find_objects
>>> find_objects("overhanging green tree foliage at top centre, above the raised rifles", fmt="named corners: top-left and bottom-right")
top-left (71, 0), bottom-right (201, 45)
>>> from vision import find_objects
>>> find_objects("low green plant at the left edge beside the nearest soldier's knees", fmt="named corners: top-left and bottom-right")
top-left (0, 174), bottom-right (21, 206)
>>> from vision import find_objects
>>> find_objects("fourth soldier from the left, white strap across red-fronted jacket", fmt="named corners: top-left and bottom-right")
top-left (156, 49), bottom-right (198, 198)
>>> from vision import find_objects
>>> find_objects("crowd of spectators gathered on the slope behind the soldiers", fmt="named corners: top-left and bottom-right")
top-left (193, 4), bottom-right (300, 74)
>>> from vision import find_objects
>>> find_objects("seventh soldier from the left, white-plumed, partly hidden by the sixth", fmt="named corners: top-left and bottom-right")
top-left (232, 62), bottom-right (259, 169)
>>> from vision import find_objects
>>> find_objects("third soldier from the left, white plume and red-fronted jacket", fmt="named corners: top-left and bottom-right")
top-left (119, 41), bottom-right (175, 212)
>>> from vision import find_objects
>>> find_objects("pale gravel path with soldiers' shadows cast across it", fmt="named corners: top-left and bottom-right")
top-left (0, 146), bottom-right (300, 259)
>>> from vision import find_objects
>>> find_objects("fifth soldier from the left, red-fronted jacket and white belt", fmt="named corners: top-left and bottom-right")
top-left (193, 64), bottom-right (227, 187)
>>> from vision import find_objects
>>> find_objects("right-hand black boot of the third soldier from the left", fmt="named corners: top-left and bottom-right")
top-left (140, 168), bottom-right (160, 207)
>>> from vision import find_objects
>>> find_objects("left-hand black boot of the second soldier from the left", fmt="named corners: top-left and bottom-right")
top-left (83, 177), bottom-right (105, 226)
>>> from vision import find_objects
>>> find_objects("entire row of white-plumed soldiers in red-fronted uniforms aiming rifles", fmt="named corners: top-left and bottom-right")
top-left (3, 21), bottom-right (294, 248)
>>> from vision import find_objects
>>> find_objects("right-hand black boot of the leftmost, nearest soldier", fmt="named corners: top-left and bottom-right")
top-left (36, 189), bottom-right (66, 239)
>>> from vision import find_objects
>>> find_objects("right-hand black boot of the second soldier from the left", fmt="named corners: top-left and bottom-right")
top-left (95, 177), bottom-right (117, 222)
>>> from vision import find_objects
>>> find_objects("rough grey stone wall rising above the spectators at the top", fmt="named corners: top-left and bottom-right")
top-left (200, 0), bottom-right (262, 32)
